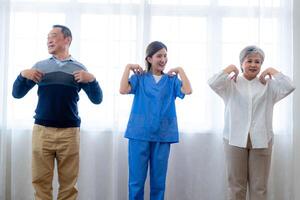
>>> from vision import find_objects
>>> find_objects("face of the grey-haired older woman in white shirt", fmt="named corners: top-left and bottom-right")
top-left (242, 53), bottom-right (262, 80)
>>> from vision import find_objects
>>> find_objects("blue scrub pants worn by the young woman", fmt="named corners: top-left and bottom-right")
top-left (128, 139), bottom-right (170, 200)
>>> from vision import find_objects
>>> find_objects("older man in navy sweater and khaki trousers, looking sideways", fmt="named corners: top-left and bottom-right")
top-left (12, 25), bottom-right (102, 200)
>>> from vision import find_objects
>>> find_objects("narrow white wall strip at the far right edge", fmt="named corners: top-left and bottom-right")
top-left (293, 0), bottom-right (300, 200)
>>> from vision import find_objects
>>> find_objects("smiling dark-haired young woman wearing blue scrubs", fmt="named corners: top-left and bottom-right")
top-left (120, 41), bottom-right (192, 200)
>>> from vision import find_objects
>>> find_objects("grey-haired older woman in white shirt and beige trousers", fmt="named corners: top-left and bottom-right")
top-left (208, 46), bottom-right (295, 200)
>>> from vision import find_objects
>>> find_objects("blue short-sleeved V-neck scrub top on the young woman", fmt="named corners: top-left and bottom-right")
top-left (125, 72), bottom-right (185, 142)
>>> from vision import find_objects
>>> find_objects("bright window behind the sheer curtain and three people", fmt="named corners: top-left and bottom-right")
top-left (8, 0), bottom-right (292, 133)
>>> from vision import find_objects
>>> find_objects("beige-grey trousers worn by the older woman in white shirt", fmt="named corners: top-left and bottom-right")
top-left (224, 139), bottom-right (272, 200)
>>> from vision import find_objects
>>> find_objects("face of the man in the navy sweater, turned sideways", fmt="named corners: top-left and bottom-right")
top-left (47, 28), bottom-right (71, 55)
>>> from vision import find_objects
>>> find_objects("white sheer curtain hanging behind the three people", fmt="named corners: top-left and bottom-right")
top-left (0, 0), bottom-right (293, 200)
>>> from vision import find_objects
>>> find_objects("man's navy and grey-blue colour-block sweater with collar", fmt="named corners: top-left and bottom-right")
top-left (12, 57), bottom-right (102, 128)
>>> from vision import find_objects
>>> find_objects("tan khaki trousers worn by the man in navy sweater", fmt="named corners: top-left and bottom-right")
top-left (32, 124), bottom-right (80, 200)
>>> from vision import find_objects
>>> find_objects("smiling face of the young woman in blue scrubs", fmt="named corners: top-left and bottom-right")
top-left (147, 48), bottom-right (168, 75)
